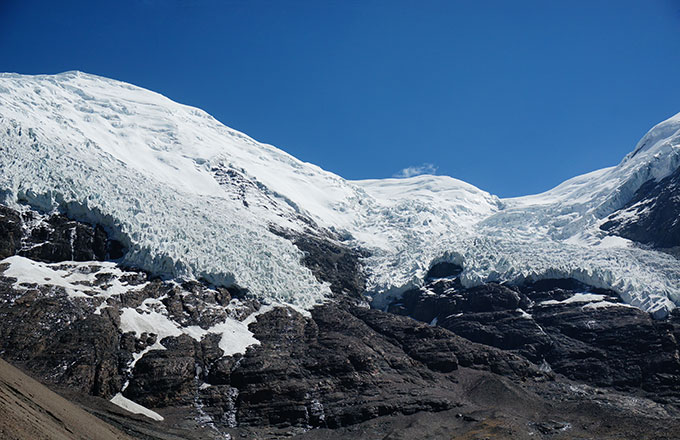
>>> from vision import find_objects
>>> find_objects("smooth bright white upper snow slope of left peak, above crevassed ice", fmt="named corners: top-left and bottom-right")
top-left (0, 71), bottom-right (356, 205)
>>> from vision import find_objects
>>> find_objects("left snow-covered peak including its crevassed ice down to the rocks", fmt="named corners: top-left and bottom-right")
top-left (0, 72), bottom-right (351, 305)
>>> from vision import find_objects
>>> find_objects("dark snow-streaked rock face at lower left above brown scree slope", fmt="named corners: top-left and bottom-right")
top-left (0, 268), bottom-right (248, 407)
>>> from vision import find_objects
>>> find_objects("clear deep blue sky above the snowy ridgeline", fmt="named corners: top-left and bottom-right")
top-left (0, 0), bottom-right (680, 196)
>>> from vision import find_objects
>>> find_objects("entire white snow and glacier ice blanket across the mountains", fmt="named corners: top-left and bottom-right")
top-left (0, 72), bottom-right (680, 316)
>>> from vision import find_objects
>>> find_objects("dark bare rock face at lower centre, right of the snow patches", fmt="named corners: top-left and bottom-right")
top-left (209, 305), bottom-right (541, 427)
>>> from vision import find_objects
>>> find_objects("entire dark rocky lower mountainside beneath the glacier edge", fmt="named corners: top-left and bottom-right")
top-left (0, 205), bottom-right (680, 438)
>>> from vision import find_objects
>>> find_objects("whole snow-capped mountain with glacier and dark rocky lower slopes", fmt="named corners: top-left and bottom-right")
top-left (0, 72), bottom-right (680, 440)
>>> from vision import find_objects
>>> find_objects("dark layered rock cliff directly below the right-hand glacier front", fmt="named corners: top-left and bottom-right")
top-left (390, 280), bottom-right (680, 402)
